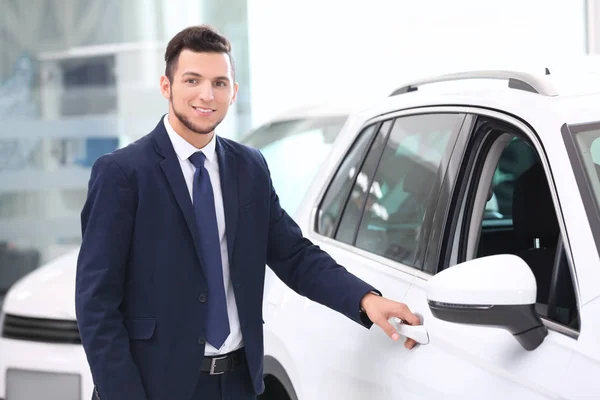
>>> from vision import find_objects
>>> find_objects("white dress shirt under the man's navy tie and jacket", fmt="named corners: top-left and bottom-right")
top-left (163, 114), bottom-right (243, 356)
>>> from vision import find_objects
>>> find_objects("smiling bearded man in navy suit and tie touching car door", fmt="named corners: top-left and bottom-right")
top-left (76, 26), bottom-right (420, 400)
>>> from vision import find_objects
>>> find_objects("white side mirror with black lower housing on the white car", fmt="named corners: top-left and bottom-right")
top-left (427, 254), bottom-right (548, 350)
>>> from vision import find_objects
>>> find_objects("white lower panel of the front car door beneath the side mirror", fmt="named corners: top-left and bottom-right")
top-left (386, 280), bottom-right (577, 399)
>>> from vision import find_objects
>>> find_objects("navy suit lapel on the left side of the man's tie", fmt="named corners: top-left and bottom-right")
top-left (153, 120), bottom-right (209, 280)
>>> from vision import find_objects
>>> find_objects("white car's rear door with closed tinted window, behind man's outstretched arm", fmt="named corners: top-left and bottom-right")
top-left (286, 109), bottom-right (465, 400)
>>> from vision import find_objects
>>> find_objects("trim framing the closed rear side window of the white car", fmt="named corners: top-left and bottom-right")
top-left (307, 106), bottom-right (470, 275)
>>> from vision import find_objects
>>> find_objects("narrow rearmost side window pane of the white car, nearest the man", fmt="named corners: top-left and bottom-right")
top-left (316, 125), bottom-right (378, 237)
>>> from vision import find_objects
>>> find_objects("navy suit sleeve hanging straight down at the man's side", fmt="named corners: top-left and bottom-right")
top-left (75, 156), bottom-right (146, 400)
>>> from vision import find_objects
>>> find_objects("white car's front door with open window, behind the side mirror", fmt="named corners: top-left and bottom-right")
top-left (386, 110), bottom-right (581, 399)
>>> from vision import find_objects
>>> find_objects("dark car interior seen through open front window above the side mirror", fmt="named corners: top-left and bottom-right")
top-left (458, 122), bottom-right (579, 330)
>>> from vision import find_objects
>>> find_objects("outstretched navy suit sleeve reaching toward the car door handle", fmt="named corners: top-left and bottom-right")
top-left (263, 152), bottom-right (379, 328)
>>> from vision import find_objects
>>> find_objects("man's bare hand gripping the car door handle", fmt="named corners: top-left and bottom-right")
top-left (360, 293), bottom-right (421, 350)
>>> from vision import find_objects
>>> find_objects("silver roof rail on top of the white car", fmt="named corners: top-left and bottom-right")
top-left (390, 70), bottom-right (558, 96)
